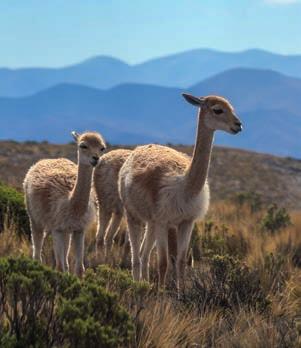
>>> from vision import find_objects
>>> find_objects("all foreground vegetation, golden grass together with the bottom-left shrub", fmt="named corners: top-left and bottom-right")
top-left (0, 188), bottom-right (301, 347)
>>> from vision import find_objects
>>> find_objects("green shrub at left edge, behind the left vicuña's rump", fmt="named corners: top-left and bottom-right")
top-left (0, 182), bottom-right (30, 237)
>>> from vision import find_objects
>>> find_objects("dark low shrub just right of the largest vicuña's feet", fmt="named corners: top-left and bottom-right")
top-left (184, 255), bottom-right (269, 312)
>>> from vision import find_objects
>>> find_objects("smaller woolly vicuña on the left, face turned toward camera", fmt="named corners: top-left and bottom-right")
top-left (24, 132), bottom-right (106, 276)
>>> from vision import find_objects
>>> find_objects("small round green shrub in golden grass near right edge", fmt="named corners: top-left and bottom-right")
top-left (261, 204), bottom-right (291, 233)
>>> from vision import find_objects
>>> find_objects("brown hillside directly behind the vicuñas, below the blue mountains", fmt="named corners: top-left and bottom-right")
top-left (0, 142), bottom-right (301, 209)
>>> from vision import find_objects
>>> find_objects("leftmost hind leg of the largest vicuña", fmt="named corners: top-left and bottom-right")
top-left (126, 213), bottom-right (143, 280)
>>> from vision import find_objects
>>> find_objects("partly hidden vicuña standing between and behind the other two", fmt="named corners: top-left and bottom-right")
top-left (94, 149), bottom-right (132, 254)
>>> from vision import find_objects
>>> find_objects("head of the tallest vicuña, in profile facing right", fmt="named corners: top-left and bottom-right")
top-left (183, 93), bottom-right (242, 134)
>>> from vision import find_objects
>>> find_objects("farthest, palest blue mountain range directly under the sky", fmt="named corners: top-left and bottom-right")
top-left (0, 49), bottom-right (301, 97)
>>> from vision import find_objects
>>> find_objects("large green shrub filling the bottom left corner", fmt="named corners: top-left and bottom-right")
top-left (0, 257), bottom-right (133, 347)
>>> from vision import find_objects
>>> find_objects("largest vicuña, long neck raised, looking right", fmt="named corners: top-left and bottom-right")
top-left (119, 94), bottom-right (242, 290)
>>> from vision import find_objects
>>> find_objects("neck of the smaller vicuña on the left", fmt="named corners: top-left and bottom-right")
top-left (70, 155), bottom-right (93, 216)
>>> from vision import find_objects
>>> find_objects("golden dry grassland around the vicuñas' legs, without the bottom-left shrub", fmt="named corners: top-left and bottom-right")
top-left (0, 201), bottom-right (301, 348)
